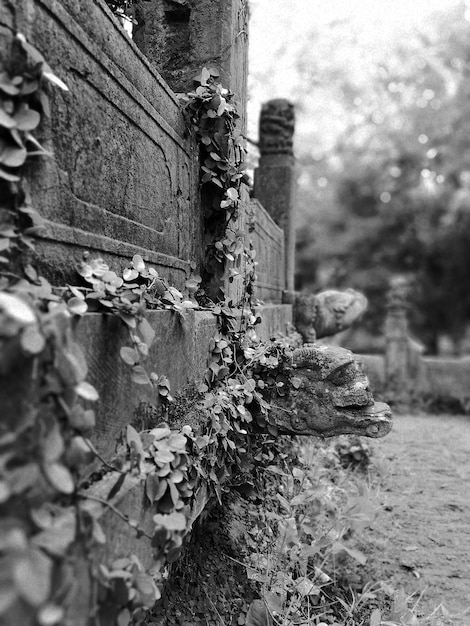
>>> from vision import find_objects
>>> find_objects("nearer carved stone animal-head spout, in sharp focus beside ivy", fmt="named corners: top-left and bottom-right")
top-left (268, 344), bottom-right (392, 437)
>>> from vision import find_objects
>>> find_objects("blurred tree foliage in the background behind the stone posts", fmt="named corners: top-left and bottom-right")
top-left (252, 2), bottom-right (470, 352)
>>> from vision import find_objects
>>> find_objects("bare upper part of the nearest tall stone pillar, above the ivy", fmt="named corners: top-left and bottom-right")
top-left (133, 0), bottom-right (248, 127)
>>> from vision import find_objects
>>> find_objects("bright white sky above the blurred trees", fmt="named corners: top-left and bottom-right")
top-left (248, 0), bottom-right (464, 137)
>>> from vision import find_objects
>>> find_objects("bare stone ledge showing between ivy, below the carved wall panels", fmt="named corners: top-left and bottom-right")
top-left (75, 305), bottom-right (292, 458)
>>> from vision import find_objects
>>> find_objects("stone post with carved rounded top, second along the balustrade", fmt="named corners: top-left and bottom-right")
top-left (254, 99), bottom-right (296, 292)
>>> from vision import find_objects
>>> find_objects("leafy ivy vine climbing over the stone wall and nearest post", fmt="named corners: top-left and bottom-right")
top-left (0, 35), bottom-right (300, 626)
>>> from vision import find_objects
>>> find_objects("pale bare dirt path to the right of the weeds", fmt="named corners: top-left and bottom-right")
top-left (368, 415), bottom-right (470, 626)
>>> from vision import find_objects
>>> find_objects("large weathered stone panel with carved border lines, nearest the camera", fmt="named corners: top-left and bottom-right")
top-left (0, 0), bottom-right (202, 287)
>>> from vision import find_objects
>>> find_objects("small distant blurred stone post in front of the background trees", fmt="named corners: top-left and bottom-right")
top-left (385, 276), bottom-right (411, 394)
